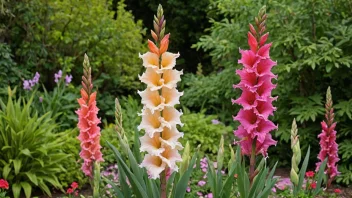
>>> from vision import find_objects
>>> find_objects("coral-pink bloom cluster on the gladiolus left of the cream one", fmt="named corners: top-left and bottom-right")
top-left (76, 91), bottom-right (104, 177)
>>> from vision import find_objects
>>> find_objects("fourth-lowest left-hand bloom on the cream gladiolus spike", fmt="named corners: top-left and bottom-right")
top-left (138, 88), bottom-right (163, 113)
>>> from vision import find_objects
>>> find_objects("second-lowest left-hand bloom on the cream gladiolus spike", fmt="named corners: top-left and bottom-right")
top-left (139, 133), bottom-right (165, 155)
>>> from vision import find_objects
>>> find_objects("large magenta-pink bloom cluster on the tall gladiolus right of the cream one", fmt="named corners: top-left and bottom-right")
top-left (232, 29), bottom-right (277, 156)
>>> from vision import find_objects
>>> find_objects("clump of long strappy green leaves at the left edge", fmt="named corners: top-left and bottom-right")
top-left (0, 88), bottom-right (69, 198)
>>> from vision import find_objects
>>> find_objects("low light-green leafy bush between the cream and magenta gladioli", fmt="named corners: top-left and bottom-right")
top-left (180, 109), bottom-right (234, 159)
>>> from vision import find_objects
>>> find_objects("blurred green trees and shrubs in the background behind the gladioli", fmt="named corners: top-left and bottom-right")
top-left (0, 0), bottom-right (352, 195)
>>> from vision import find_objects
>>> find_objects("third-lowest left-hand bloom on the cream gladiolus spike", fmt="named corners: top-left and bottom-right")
top-left (138, 108), bottom-right (165, 137)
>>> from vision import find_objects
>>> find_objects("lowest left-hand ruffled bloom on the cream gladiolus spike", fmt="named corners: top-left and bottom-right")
top-left (140, 154), bottom-right (166, 179)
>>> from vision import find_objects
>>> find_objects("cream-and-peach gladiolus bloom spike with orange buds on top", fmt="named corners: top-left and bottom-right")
top-left (138, 17), bottom-right (183, 179)
